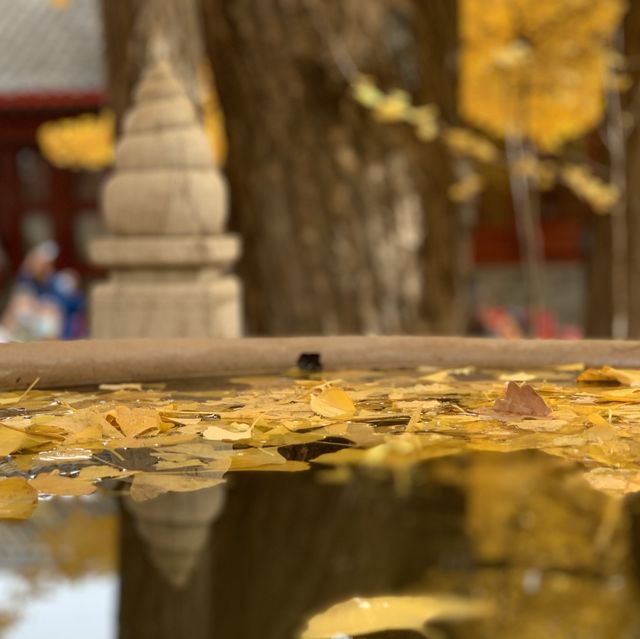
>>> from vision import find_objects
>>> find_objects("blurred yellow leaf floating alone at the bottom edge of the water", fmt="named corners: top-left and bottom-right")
top-left (300, 595), bottom-right (491, 639)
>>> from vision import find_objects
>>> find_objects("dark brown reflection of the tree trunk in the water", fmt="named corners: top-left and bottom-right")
top-left (120, 460), bottom-right (464, 639)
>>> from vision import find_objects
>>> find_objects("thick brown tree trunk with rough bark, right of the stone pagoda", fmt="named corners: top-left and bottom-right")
top-left (203, 0), bottom-right (456, 335)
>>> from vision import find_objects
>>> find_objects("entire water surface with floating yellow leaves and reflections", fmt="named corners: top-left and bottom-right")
top-left (0, 371), bottom-right (640, 639)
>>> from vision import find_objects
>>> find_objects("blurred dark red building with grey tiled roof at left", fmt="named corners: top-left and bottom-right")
top-left (0, 0), bottom-right (104, 281)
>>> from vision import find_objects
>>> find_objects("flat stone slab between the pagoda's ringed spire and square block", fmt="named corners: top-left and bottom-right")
top-left (89, 234), bottom-right (241, 269)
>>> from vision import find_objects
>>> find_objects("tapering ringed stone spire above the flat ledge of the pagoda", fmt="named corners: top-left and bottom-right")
top-left (102, 53), bottom-right (227, 236)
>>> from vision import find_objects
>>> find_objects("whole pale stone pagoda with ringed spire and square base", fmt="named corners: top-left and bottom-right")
top-left (89, 50), bottom-right (241, 338)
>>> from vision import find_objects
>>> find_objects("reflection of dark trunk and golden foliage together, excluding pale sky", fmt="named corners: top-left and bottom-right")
top-left (121, 453), bottom-right (640, 639)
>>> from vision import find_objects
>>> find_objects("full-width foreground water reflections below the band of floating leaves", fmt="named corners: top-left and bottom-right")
top-left (0, 444), bottom-right (640, 639)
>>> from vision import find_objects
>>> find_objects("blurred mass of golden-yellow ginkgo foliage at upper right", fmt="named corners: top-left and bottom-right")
top-left (459, 0), bottom-right (625, 152)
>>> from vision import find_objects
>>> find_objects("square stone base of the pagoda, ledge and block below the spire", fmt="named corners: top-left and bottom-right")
top-left (90, 235), bottom-right (242, 338)
